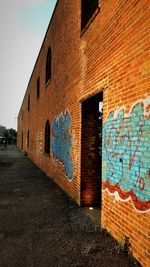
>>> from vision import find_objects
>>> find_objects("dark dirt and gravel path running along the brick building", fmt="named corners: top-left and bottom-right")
top-left (0, 149), bottom-right (140, 267)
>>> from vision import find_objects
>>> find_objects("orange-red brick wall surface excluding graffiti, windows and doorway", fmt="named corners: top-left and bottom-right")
top-left (18, 0), bottom-right (150, 266)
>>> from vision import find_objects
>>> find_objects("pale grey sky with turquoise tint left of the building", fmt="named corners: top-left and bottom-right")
top-left (0, 0), bottom-right (57, 129)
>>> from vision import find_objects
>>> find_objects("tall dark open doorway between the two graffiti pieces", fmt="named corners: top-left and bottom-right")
top-left (81, 92), bottom-right (103, 208)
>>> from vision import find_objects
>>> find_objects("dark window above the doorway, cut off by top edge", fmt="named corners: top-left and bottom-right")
top-left (81, 0), bottom-right (99, 30)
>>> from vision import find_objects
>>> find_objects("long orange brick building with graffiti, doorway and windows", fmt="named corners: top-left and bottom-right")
top-left (18, 0), bottom-right (150, 266)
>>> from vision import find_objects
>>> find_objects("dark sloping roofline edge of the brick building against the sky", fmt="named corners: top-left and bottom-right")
top-left (18, 0), bottom-right (59, 117)
